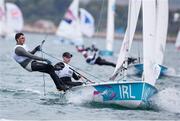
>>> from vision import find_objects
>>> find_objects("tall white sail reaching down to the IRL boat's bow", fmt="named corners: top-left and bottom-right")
top-left (142, 0), bottom-right (157, 85)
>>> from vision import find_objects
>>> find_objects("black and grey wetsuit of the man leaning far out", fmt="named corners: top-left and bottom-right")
top-left (15, 47), bottom-right (67, 90)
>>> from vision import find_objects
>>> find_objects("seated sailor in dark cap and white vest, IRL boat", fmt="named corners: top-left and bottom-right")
top-left (54, 52), bottom-right (83, 87)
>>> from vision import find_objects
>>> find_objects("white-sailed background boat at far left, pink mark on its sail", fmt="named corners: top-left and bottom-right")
top-left (0, 0), bottom-right (24, 38)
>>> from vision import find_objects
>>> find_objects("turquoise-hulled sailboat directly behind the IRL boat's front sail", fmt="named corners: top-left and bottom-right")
top-left (132, 0), bottom-right (169, 76)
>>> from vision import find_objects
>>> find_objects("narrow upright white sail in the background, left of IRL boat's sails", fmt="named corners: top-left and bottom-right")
top-left (106, 0), bottom-right (115, 51)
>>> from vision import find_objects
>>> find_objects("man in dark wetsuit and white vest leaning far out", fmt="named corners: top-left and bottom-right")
top-left (13, 33), bottom-right (68, 91)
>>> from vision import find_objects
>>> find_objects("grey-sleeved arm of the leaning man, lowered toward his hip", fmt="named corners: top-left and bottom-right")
top-left (15, 47), bottom-right (46, 61)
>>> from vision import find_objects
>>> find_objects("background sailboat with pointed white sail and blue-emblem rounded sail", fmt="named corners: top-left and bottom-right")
top-left (56, 0), bottom-right (94, 46)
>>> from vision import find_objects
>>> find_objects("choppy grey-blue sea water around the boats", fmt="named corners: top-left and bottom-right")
top-left (0, 34), bottom-right (180, 120)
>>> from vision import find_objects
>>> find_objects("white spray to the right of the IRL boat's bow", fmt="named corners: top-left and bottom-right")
top-left (152, 88), bottom-right (180, 113)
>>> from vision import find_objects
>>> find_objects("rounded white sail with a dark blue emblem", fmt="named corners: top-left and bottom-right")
top-left (80, 8), bottom-right (95, 37)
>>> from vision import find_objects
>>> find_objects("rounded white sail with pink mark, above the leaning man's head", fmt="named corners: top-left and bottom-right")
top-left (6, 3), bottom-right (24, 32)
